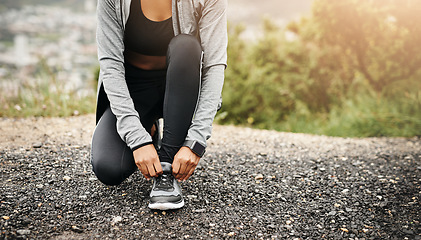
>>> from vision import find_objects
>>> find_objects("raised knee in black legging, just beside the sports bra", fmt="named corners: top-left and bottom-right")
top-left (168, 34), bottom-right (202, 59)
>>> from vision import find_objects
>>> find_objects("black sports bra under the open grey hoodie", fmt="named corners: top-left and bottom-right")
top-left (124, 0), bottom-right (174, 56)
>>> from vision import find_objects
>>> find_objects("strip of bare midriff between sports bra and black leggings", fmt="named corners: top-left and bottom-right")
top-left (124, 49), bottom-right (167, 70)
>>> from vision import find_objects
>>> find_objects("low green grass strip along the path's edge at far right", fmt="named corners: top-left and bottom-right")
top-left (275, 94), bottom-right (421, 137)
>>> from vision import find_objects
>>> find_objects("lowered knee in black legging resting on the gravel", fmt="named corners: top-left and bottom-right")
top-left (91, 156), bottom-right (124, 186)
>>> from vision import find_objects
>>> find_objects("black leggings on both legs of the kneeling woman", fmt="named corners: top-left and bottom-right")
top-left (91, 35), bottom-right (202, 185)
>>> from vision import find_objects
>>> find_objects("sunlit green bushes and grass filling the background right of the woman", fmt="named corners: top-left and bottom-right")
top-left (217, 0), bottom-right (421, 136)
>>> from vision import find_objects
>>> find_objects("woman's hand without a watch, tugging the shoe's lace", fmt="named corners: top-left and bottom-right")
top-left (133, 144), bottom-right (162, 180)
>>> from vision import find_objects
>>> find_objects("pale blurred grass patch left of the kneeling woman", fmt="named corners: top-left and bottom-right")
top-left (0, 64), bottom-right (96, 117)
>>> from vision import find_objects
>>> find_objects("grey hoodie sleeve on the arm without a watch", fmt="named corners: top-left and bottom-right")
top-left (96, 0), bottom-right (152, 150)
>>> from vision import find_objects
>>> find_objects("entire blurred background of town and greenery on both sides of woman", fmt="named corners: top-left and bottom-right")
top-left (0, 0), bottom-right (421, 137)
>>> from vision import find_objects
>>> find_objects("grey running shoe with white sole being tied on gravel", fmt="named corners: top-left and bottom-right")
top-left (148, 162), bottom-right (184, 210)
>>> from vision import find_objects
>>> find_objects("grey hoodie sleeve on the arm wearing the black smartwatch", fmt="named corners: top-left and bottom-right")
top-left (186, 0), bottom-right (228, 146)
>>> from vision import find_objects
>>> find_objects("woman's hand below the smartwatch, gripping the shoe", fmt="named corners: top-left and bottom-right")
top-left (172, 147), bottom-right (200, 181)
